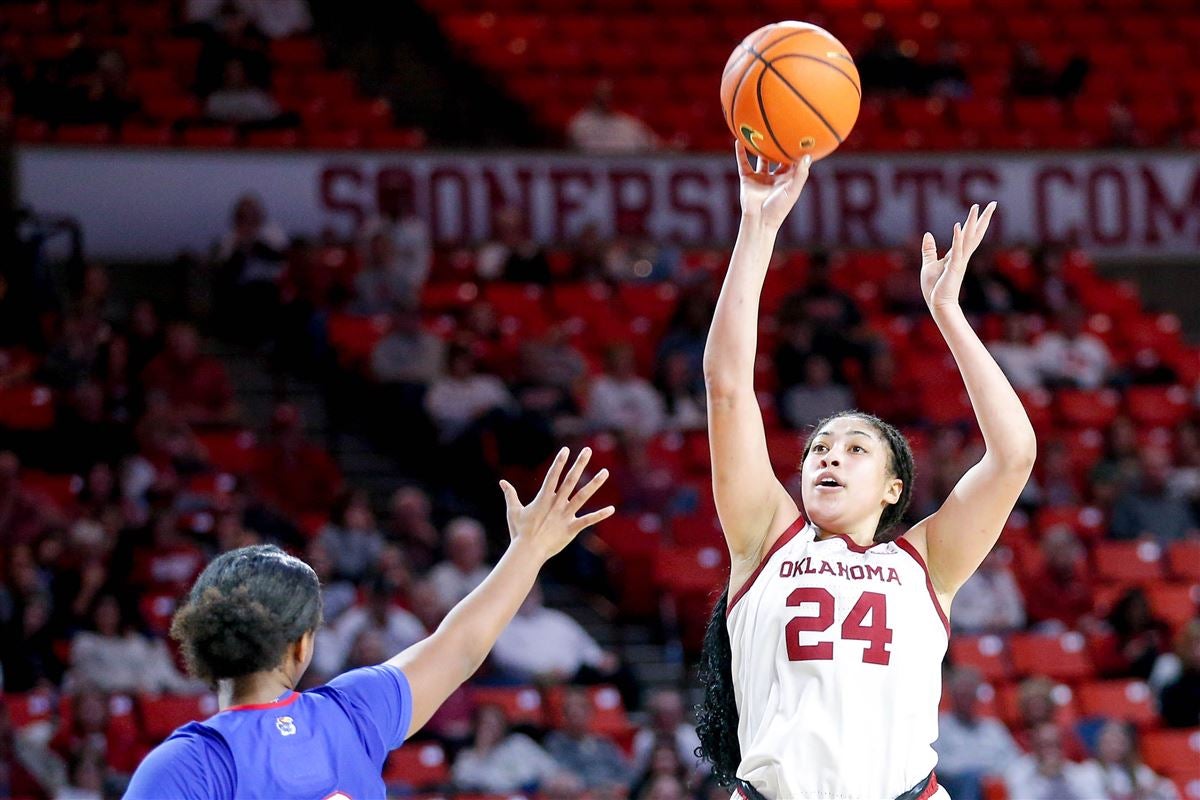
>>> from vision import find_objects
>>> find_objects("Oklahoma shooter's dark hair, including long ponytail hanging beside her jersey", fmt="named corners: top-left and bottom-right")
top-left (696, 410), bottom-right (916, 786)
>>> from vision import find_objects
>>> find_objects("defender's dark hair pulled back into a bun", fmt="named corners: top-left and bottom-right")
top-left (170, 545), bottom-right (322, 685)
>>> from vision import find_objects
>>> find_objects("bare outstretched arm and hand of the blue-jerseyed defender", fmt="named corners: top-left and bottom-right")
top-left (388, 447), bottom-right (613, 736)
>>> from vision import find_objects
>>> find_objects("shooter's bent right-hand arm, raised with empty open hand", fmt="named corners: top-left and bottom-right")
top-left (910, 203), bottom-right (1037, 604)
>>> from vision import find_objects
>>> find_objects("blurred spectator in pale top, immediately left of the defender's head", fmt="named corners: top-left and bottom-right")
top-left (70, 595), bottom-right (206, 694)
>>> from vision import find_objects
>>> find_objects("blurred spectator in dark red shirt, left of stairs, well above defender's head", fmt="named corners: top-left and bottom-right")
top-left (142, 323), bottom-right (238, 425)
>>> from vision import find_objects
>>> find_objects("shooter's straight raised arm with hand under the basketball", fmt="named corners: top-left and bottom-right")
top-left (704, 143), bottom-right (810, 568)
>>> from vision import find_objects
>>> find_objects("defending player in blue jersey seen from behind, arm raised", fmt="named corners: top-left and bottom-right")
top-left (125, 449), bottom-right (613, 800)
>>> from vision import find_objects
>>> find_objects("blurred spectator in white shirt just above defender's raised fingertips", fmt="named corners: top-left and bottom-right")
top-left (587, 344), bottom-right (665, 438)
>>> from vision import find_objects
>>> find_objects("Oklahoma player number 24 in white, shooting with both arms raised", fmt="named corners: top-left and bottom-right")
top-left (697, 145), bottom-right (1036, 800)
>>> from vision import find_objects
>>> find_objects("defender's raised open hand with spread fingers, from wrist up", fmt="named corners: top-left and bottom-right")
top-left (500, 447), bottom-right (616, 560)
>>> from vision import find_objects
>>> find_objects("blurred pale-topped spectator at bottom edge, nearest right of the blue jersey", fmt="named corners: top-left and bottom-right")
top-left (450, 705), bottom-right (558, 794)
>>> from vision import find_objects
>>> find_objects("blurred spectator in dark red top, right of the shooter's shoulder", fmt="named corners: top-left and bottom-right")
top-left (1025, 528), bottom-right (1092, 631)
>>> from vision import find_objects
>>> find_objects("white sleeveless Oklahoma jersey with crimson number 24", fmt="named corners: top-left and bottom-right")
top-left (727, 518), bottom-right (949, 800)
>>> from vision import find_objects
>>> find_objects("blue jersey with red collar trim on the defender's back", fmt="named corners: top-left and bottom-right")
top-left (125, 664), bottom-right (413, 800)
